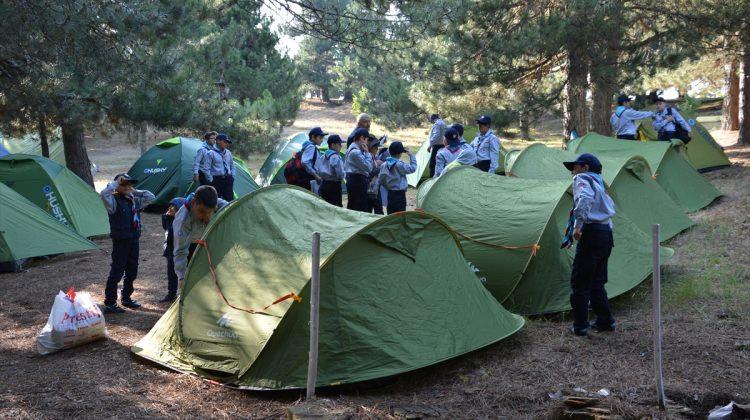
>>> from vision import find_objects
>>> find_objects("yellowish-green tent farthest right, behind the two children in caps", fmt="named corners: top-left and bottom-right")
top-left (638, 110), bottom-right (731, 172)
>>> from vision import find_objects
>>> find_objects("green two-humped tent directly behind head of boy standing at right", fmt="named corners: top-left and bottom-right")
top-left (505, 143), bottom-right (693, 240)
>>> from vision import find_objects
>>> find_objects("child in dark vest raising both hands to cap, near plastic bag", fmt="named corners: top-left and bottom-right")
top-left (99, 174), bottom-right (156, 314)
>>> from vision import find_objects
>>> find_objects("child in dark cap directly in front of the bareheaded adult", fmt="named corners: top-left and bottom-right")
top-left (344, 128), bottom-right (375, 212)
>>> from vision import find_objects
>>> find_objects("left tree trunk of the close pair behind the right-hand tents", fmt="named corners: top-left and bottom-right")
top-left (563, 48), bottom-right (588, 143)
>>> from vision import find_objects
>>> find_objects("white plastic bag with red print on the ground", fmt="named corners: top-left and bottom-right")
top-left (36, 287), bottom-right (107, 354)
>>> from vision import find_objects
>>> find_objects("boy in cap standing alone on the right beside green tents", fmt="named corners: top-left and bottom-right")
top-left (562, 153), bottom-right (615, 336)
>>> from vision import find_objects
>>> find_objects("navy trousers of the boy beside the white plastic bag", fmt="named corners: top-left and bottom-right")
top-left (104, 239), bottom-right (140, 306)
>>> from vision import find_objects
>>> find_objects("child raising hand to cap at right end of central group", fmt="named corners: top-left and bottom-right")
top-left (379, 141), bottom-right (417, 214)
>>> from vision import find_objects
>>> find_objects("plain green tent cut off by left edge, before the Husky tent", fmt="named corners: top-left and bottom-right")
top-left (0, 183), bottom-right (96, 263)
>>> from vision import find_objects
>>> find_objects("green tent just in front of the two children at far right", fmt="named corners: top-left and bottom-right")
top-left (568, 133), bottom-right (722, 212)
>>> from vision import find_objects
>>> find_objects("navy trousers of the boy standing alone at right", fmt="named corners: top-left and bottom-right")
top-left (570, 224), bottom-right (615, 330)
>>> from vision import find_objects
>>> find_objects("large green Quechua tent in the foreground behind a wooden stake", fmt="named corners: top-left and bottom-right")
top-left (133, 185), bottom-right (523, 389)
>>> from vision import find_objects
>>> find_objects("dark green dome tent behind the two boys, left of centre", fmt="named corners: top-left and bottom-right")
top-left (128, 137), bottom-right (259, 206)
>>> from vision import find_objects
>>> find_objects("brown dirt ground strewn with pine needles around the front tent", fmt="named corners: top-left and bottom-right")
top-left (0, 107), bottom-right (750, 418)
